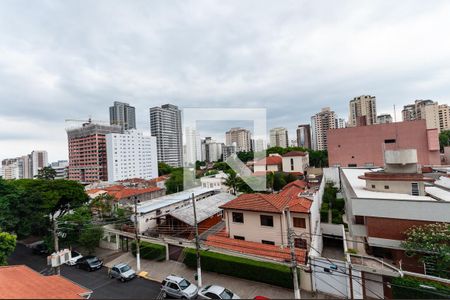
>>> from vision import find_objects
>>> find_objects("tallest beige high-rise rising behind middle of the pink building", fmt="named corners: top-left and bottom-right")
top-left (348, 95), bottom-right (377, 127)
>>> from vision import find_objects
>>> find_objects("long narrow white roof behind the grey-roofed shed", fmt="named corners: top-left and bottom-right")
top-left (137, 187), bottom-right (215, 214)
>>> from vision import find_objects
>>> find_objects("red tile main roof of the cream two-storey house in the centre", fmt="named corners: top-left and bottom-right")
top-left (221, 180), bottom-right (312, 213)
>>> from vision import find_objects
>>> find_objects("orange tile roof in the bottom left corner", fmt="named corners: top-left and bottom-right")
top-left (0, 265), bottom-right (92, 299)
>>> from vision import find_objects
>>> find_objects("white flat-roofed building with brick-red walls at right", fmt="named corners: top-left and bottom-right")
top-left (340, 149), bottom-right (450, 272)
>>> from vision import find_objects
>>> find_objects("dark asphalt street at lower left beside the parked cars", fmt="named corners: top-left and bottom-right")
top-left (8, 244), bottom-right (161, 299)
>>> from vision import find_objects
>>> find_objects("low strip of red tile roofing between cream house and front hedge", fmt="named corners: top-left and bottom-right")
top-left (206, 235), bottom-right (306, 264)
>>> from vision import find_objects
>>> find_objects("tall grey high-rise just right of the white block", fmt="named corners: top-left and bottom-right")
top-left (150, 104), bottom-right (183, 167)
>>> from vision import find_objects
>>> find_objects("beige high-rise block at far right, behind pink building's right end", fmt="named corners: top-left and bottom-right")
top-left (402, 100), bottom-right (444, 132)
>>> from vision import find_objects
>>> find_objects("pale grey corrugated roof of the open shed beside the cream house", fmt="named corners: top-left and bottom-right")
top-left (169, 193), bottom-right (236, 226)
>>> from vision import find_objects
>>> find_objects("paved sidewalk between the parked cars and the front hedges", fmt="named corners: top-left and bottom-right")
top-left (105, 253), bottom-right (324, 299)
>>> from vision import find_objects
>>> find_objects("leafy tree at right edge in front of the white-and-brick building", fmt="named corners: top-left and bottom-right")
top-left (402, 223), bottom-right (450, 278)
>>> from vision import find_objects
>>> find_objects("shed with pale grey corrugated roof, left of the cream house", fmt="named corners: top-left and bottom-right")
top-left (158, 193), bottom-right (236, 239)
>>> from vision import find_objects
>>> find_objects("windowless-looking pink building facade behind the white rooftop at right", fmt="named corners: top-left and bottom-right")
top-left (328, 120), bottom-right (441, 167)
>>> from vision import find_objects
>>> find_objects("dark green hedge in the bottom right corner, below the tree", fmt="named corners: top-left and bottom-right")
top-left (392, 276), bottom-right (450, 299)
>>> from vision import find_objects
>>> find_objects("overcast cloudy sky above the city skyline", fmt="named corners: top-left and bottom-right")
top-left (0, 0), bottom-right (450, 160)
